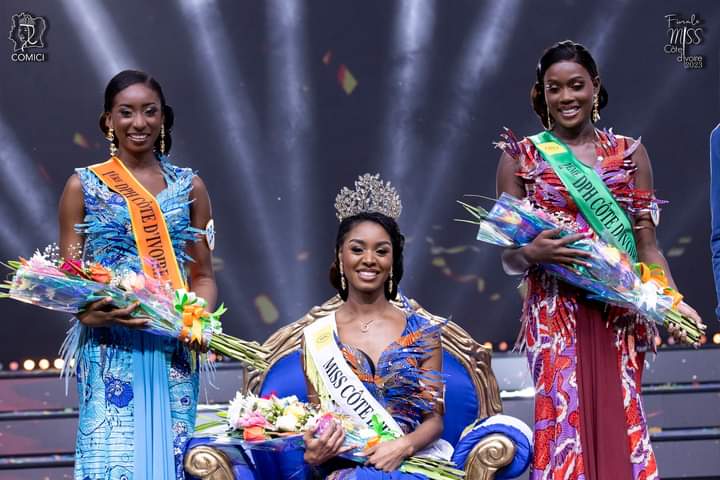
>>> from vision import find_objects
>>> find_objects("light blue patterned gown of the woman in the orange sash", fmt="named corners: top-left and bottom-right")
top-left (72, 157), bottom-right (204, 480)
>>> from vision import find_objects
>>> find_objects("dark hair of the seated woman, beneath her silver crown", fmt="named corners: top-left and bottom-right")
top-left (330, 212), bottom-right (405, 300)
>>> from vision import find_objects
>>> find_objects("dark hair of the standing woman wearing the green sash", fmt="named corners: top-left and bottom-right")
top-left (530, 40), bottom-right (608, 128)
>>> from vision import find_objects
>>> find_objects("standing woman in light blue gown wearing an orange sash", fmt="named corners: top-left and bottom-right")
top-left (59, 70), bottom-right (217, 480)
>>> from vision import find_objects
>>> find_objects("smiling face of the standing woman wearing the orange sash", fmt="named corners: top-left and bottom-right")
top-left (105, 83), bottom-right (163, 155)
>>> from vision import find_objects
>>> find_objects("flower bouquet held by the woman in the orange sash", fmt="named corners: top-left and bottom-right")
top-left (0, 246), bottom-right (268, 369)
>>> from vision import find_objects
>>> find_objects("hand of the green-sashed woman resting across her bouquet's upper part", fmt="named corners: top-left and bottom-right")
top-left (520, 228), bottom-right (592, 267)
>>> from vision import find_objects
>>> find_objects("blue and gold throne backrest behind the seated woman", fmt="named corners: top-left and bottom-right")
top-left (243, 295), bottom-right (502, 444)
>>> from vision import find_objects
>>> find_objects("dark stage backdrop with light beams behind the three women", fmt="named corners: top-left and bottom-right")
top-left (0, 0), bottom-right (720, 368)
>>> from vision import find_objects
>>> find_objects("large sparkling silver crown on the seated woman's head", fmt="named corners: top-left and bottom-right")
top-left (335, 173), bottom-right (402, 222)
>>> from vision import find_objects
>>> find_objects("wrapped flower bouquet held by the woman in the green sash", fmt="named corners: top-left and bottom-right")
top-left (458, 193), bottom-right (703, 344)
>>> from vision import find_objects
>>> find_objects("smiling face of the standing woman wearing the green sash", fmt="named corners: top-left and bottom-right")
top-left (543, 60), bottom-right (600, 129)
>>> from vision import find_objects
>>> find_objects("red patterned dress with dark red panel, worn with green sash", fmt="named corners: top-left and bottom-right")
top-left (497, 130), bottom-right (659, 480)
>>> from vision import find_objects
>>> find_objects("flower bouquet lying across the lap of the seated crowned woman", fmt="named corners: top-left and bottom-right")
top-left (195, 392), bottom-right (465, 480)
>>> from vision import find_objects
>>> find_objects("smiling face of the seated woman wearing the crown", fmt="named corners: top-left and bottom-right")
top-left (339, 221), bottom-right (393, 295)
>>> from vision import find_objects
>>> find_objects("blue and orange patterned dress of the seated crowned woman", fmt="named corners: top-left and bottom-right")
top-left (323, 307), bottom-right (444, 480)
